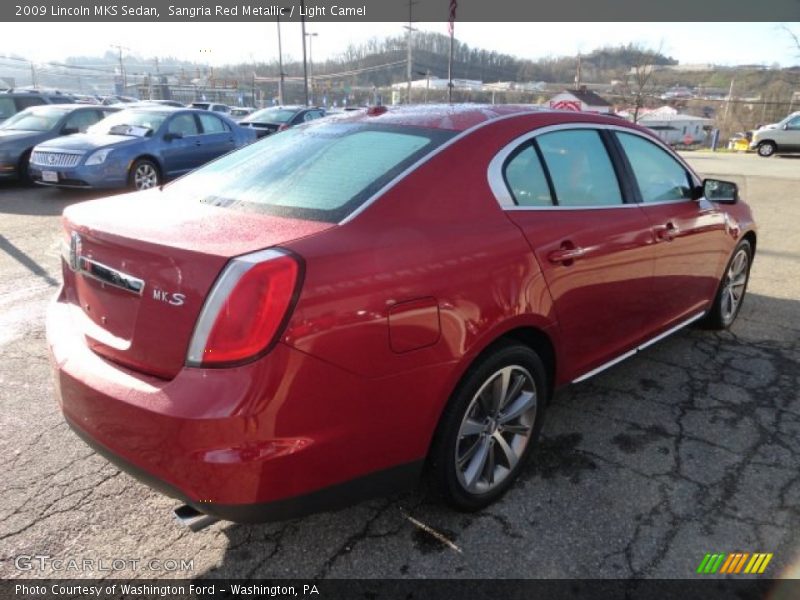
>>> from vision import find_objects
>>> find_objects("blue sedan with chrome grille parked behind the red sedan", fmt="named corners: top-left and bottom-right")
top-left (28, 106), bottom-right (256, 190)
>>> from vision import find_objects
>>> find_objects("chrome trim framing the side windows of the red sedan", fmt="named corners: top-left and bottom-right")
top-left (486, 122), bottom-right (700, 211)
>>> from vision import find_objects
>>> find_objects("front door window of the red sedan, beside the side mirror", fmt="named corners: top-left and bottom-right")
top-left (617, 133), bottom-right (692, 203)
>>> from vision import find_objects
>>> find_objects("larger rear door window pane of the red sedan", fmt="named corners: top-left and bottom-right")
top-left (536, 129), bottom-right (623, 207)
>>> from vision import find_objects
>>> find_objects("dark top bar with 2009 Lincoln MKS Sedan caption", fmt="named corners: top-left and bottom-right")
top-left (0, 0), bottom-right (800, 22)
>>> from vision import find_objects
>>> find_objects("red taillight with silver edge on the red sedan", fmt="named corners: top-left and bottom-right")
top-left (186, 250), bottom-right (301, 367)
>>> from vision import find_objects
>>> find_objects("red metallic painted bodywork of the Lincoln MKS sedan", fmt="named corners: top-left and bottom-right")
top-left (47, 106), bottom-right (753, 509)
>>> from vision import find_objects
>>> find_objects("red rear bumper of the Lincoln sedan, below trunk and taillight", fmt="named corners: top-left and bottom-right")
top-left (47, 292), bottom-right (440, 522)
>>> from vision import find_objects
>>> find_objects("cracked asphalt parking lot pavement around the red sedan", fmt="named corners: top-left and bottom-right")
top-left (0, 153), bottom-right (800, 578)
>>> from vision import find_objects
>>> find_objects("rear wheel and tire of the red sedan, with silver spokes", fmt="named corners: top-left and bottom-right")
top-left (429, 344), bottom-right (549, 511)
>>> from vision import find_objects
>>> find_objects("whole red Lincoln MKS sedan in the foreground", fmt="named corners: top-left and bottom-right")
top-left (47, 105), bottom-right (756, 521)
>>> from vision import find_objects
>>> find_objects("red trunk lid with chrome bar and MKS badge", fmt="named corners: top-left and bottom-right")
top-left (64, 190), bottom-right (334, 378)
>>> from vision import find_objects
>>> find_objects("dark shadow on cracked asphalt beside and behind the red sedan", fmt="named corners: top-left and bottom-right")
top-left (190, 294), bottom-right (800, 579)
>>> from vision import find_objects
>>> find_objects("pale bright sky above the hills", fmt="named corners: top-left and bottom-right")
top-left (0, 22), bottom-right (800, 67)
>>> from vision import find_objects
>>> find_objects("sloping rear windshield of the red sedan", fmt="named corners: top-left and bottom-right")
top-left (166, 123), bottom-right (454, 223)
